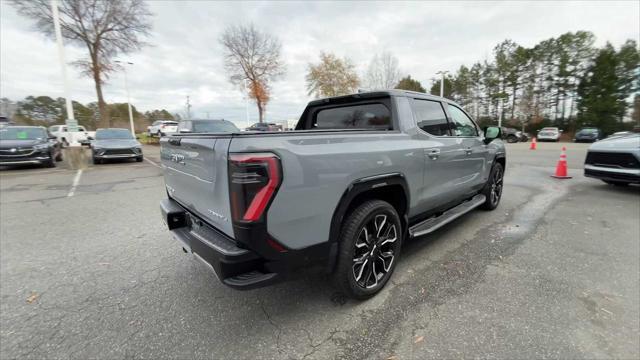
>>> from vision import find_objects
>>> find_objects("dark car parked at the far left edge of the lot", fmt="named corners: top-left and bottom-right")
top-left (0, 126), bottom-right (62, 167)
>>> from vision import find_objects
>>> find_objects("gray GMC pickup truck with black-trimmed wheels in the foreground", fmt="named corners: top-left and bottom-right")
top-left (161, 90), bottom-right (506, 299)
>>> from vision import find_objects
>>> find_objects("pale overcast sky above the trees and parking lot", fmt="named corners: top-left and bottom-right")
top-left (0, 0), bottom-right (640, 124)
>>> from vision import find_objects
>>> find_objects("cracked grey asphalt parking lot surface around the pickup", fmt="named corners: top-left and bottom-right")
top-left (0, 143), bottom-right (640, 359)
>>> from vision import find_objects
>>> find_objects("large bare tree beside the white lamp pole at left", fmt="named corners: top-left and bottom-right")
top-left (13, 0), bottom-right (151, 127)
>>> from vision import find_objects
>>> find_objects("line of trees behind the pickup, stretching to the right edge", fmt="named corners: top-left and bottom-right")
top-left (306, 31), bottom-right (640, 133)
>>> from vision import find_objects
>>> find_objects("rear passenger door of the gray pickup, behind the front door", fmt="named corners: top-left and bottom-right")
top-left (411, 99), bottom-right (462, 212)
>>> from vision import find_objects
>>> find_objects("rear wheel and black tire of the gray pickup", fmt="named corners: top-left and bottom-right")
top-left (333, 200), bottom-right (404, 300)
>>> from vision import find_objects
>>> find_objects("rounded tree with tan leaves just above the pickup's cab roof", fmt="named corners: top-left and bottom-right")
top-left (306, 52), bottom-right (360, 97)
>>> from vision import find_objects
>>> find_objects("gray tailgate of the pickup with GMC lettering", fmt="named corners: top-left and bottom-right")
top-left (160, 135), bottom-right (234, 238)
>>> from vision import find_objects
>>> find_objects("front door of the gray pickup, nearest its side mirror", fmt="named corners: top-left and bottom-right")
top-left (444, 103), bottom-right (488, 196)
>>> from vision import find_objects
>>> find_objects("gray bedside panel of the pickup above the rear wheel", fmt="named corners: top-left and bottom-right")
top-left (229, 132), bottom-right (424, 249)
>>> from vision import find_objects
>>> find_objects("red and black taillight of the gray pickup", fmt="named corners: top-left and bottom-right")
top-left (229, 153), bottom-right (282, 222)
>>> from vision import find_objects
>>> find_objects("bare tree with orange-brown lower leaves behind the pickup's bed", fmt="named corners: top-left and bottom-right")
top-left (220, 24), bottom-right (285, 122)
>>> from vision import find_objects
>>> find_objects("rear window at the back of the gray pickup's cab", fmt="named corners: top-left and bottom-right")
top-left (312, 103), bottom-right (393, 130)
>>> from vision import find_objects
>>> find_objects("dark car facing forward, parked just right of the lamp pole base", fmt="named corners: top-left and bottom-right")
top-left (91, 128), bottom-right (143, 164)
